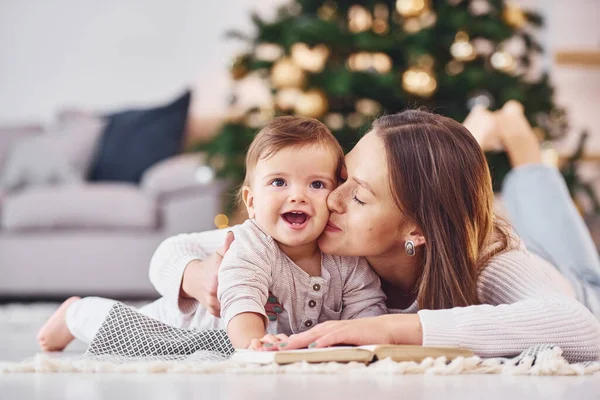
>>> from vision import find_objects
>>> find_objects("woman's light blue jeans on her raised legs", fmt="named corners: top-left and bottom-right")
top-left (502, 164), bottom-right (600, 318)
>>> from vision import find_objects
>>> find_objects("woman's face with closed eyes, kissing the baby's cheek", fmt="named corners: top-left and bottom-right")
top-left (319, 131), bottom-right (405, 257)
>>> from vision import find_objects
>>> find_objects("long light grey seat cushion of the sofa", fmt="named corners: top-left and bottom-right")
top-left (0, 183), bottom-right (158, 231)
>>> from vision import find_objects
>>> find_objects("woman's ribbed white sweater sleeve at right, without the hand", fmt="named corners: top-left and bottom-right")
top-left (418, 250), bottom-right (600, 361)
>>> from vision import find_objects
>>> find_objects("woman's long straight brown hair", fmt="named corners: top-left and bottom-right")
top-left (373, 110), bottom-right (511, 309)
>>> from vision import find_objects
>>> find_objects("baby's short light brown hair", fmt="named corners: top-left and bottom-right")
top-left (238, 116), bottom-right (344, 200)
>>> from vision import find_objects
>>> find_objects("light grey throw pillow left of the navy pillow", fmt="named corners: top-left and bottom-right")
top-left (0, 117), bottom-right (105, 191)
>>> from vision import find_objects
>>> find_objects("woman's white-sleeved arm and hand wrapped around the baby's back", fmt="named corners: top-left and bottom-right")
top-left (149, 229), bottom-right (233, 314)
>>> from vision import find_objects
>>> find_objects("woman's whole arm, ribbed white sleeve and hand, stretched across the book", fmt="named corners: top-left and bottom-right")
top-left (286, 250), bottom-right (600, 362)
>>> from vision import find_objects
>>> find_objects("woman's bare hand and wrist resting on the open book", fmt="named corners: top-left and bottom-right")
top-left (279, 314), bottom-right (423, 350)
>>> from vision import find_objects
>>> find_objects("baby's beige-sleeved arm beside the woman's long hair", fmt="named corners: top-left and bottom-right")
top-left (340, 257), bottom-right (387, 319)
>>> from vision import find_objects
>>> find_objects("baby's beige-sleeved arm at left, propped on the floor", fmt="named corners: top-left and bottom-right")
top-left (217, 223), bottom-right (276, 348)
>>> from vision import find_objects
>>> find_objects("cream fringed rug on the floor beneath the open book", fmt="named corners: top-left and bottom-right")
top-left (0, 347), bottom-right (600, 376)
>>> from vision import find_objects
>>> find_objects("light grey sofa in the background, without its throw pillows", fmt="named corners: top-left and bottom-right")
top-left (0, 123), bottom-right (223, 298)
